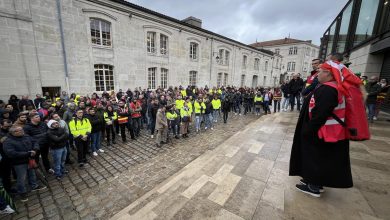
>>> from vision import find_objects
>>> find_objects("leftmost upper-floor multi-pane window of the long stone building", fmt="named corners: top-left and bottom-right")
top-left (90, 19), bottom-right (111, 46)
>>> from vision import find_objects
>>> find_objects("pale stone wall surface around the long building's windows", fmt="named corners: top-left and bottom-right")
top-left (0, 0), bottom-right (280, 100)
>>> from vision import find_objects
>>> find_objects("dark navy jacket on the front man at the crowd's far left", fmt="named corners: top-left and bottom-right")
top-left (3, 135), bottom-right (39, 165)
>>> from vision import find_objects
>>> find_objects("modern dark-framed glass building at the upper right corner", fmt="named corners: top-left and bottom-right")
top-left (320, 0), bottom-right (390, 112)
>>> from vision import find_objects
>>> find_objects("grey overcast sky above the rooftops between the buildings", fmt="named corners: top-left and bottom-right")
top-left (127, 0), bottom-right (348, 45)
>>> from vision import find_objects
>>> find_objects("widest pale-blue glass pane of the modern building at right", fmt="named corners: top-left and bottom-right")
top-left (353, 0), bottom-right (380, 46)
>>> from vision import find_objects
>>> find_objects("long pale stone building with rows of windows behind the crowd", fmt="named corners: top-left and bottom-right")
top-left (0, 0), bottom-right (282, 100)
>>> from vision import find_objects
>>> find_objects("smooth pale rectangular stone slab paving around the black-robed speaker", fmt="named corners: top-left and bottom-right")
top-left (112, 113), bottom-right (390, 220)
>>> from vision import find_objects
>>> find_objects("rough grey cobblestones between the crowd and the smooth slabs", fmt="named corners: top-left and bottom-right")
top-left (0, 114), bottom-right (258, 220)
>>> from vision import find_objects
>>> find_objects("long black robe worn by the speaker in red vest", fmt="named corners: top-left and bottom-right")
top-left (289, 85), bottom-right (353, 188)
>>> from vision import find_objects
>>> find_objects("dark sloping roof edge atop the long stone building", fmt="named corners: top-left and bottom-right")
top-left (100, 0), bottom-right (274, 56)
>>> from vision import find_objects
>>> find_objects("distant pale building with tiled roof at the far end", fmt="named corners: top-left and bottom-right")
top-left (251, 38), bottom-right (320, 80)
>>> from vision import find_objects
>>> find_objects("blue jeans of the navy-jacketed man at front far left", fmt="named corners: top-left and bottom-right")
top-left (14, 164), bottom-right (38, 193)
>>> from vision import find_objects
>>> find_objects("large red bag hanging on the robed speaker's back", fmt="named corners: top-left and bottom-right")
top-left (327, 61), bottom-right (370, 141)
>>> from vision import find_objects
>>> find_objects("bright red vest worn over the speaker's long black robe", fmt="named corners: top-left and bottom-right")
top-left (309, 82), bottom-right (347, 142)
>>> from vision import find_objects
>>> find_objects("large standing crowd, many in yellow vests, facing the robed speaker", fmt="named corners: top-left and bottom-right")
top-left (0, 52), bottom-right (389, 213)
